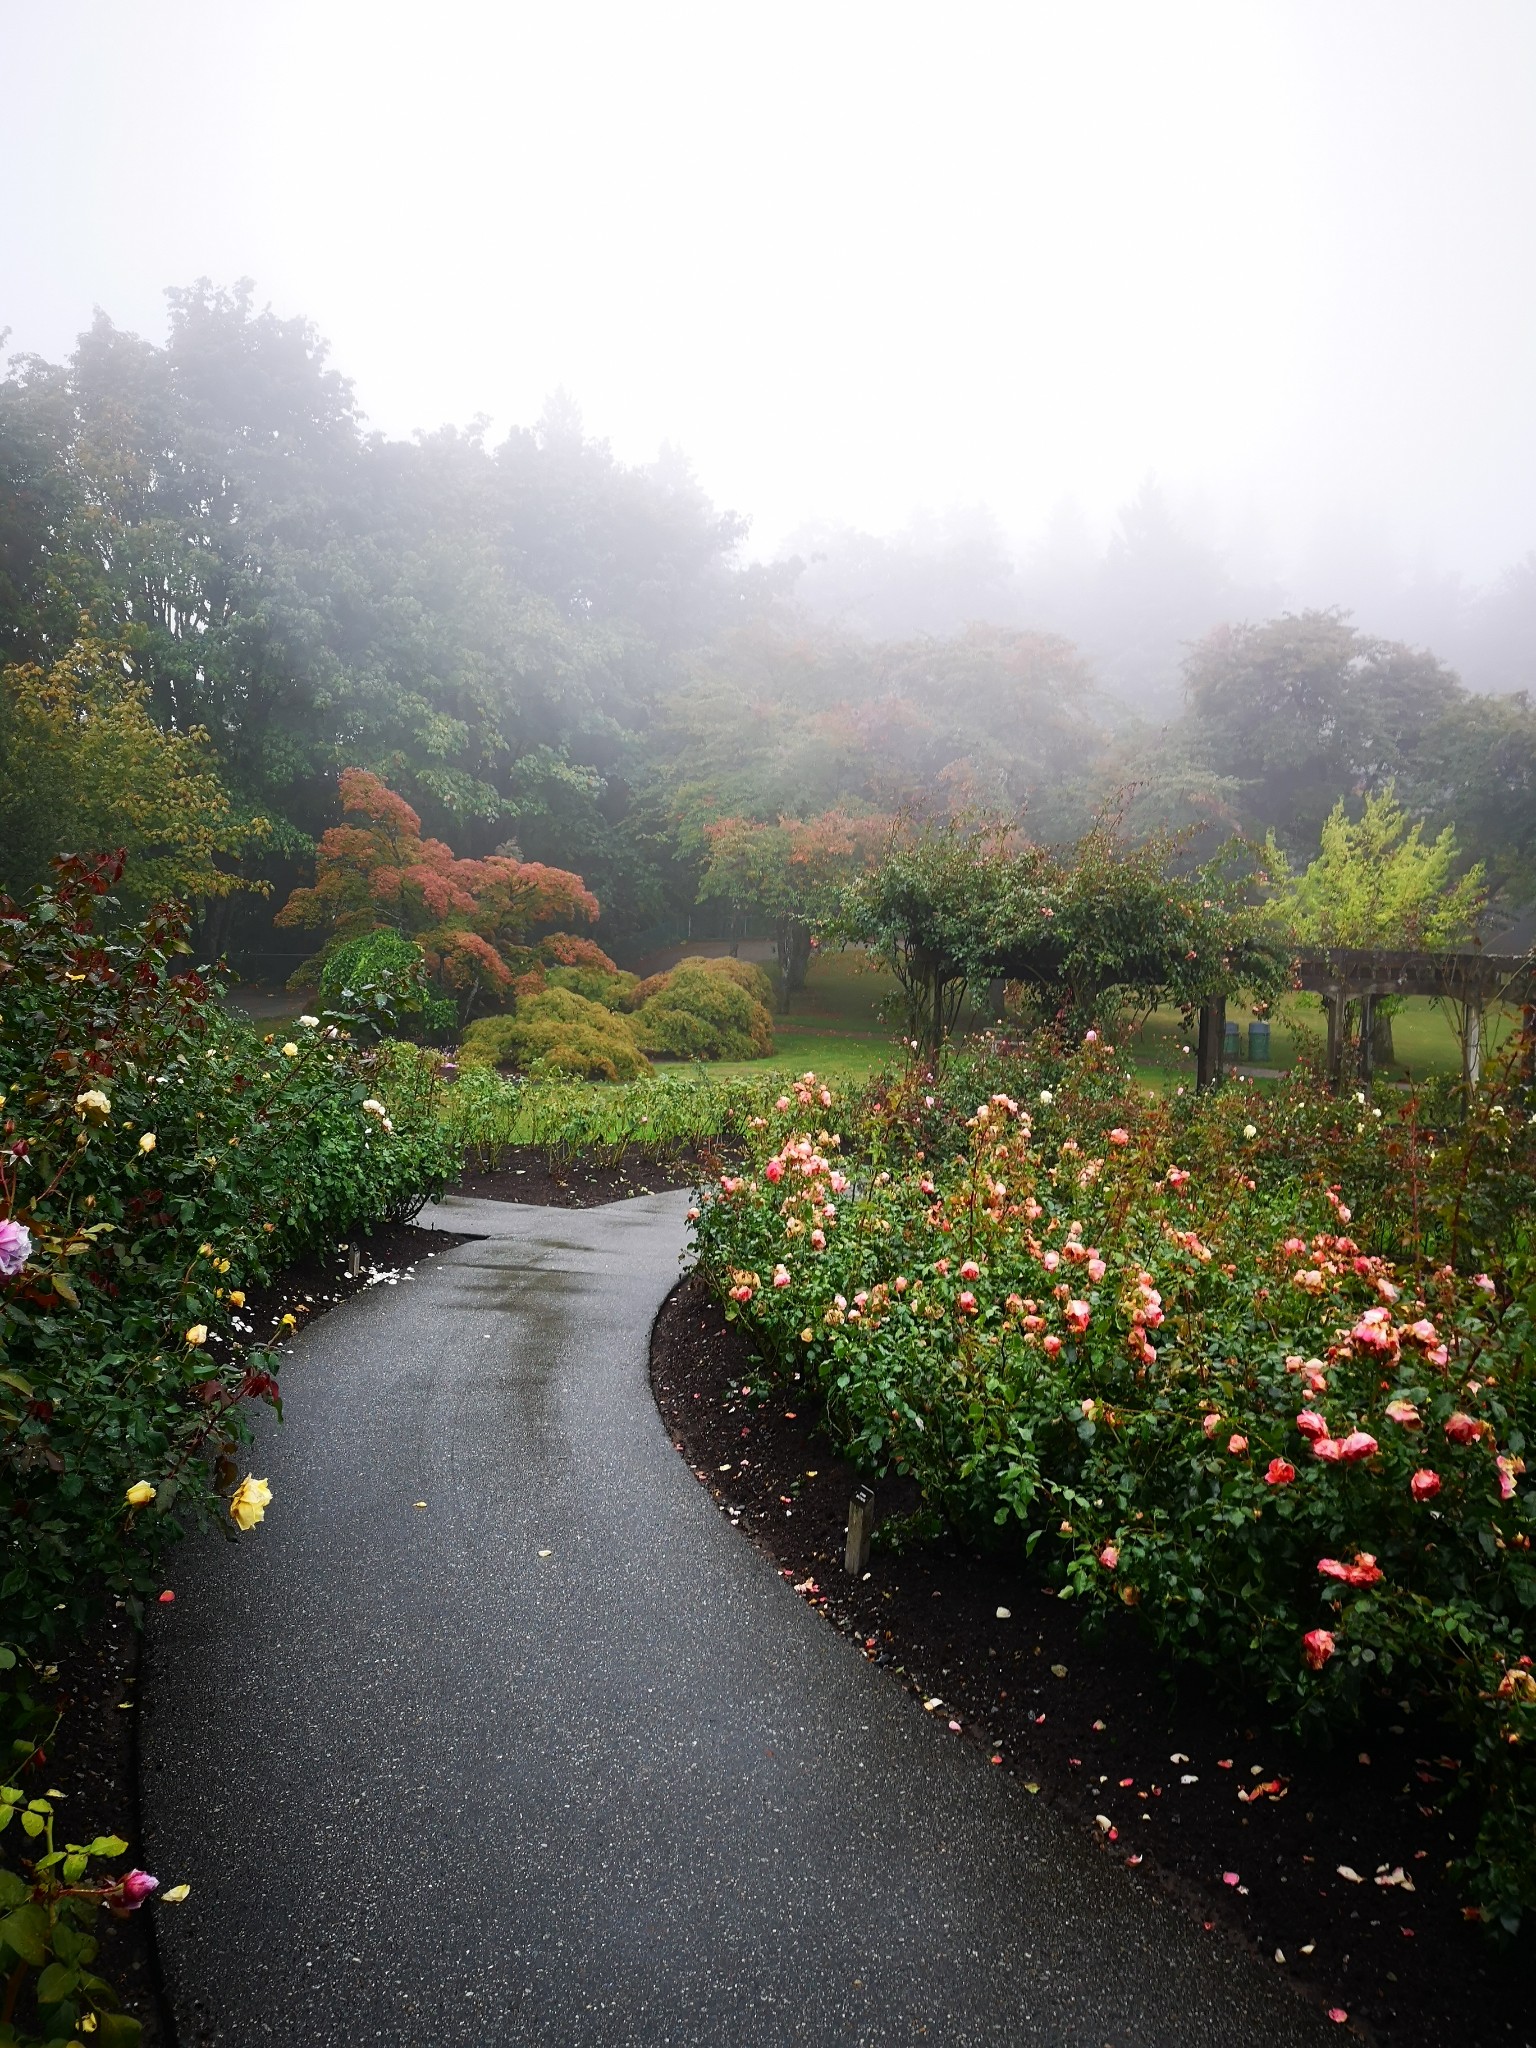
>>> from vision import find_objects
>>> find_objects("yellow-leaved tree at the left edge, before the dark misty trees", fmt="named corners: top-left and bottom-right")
top-left (0, 618), bottom-right (268, 903)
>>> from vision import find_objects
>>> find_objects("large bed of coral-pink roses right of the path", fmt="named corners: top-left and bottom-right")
top-left (696, 1038), bottom-right (1536, 1931)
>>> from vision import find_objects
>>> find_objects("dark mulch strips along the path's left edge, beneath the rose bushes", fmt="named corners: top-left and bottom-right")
top-left (23, 1223), bottom-right (473, 2048)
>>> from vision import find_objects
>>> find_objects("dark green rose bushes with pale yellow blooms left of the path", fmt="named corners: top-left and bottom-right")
top-left (0, 858), bottom-right (457, 1651)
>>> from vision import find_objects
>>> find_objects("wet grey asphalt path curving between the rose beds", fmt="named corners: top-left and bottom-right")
top-left (141, 1194), bottom-right (1337, 2048)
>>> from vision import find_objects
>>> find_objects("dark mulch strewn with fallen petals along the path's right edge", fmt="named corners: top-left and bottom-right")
top-left (651, 1280), bottom-right (1536, 2048)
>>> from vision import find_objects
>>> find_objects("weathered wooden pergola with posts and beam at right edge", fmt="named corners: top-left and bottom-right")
top-left (1196, 946), bottom-right (1536, 1087)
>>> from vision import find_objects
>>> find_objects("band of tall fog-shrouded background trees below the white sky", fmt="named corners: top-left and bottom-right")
top-left (0, 283), bottom-right (1536, 965)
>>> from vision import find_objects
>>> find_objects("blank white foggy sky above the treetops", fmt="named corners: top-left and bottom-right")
top-left (0, 0), bottom-right (1536, 596)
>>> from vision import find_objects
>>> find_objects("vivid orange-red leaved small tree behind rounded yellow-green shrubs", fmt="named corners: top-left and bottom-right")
top-left (276, 768), bottom-right (606, 1018)
